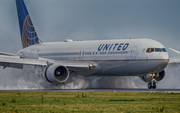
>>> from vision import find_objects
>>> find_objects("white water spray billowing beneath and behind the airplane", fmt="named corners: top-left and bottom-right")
top-left (0, 64), bottom-right (180, 90)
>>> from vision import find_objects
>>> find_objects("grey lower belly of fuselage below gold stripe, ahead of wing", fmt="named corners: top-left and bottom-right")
top-left (99, 60), bottom-right (168, 76)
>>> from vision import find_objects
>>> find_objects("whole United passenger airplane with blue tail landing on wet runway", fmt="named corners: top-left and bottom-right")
top-left (0, 0), bottom-right (169, 89)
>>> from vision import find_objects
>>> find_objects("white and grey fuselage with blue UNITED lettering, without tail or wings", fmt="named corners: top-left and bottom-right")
top-left (19, 39), bottom-right (169, 76)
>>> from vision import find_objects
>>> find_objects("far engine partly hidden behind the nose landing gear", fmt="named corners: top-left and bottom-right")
top-left (140, 70), bottom-right (166, 82)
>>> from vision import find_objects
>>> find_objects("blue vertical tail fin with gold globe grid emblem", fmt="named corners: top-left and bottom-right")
top-left (16, 0), bottom-right (40, 48)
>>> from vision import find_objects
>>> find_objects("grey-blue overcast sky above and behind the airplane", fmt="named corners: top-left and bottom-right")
top-left (0, 0), bottom-right (180, 57)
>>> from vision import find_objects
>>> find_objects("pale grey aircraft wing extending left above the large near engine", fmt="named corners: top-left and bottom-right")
top-left (0, 55), bottom-right (91, 70)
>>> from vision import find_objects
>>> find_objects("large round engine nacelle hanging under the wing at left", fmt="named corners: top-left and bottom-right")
top-left (43, 65), bottom-right (69, 83)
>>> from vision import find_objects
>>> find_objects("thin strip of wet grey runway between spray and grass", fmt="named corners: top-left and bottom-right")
top-left (0, 89), bottom-right (180, 93)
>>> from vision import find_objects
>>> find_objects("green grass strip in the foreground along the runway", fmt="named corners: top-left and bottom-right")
top-left (0, 91), bottom-right (180, 113)
